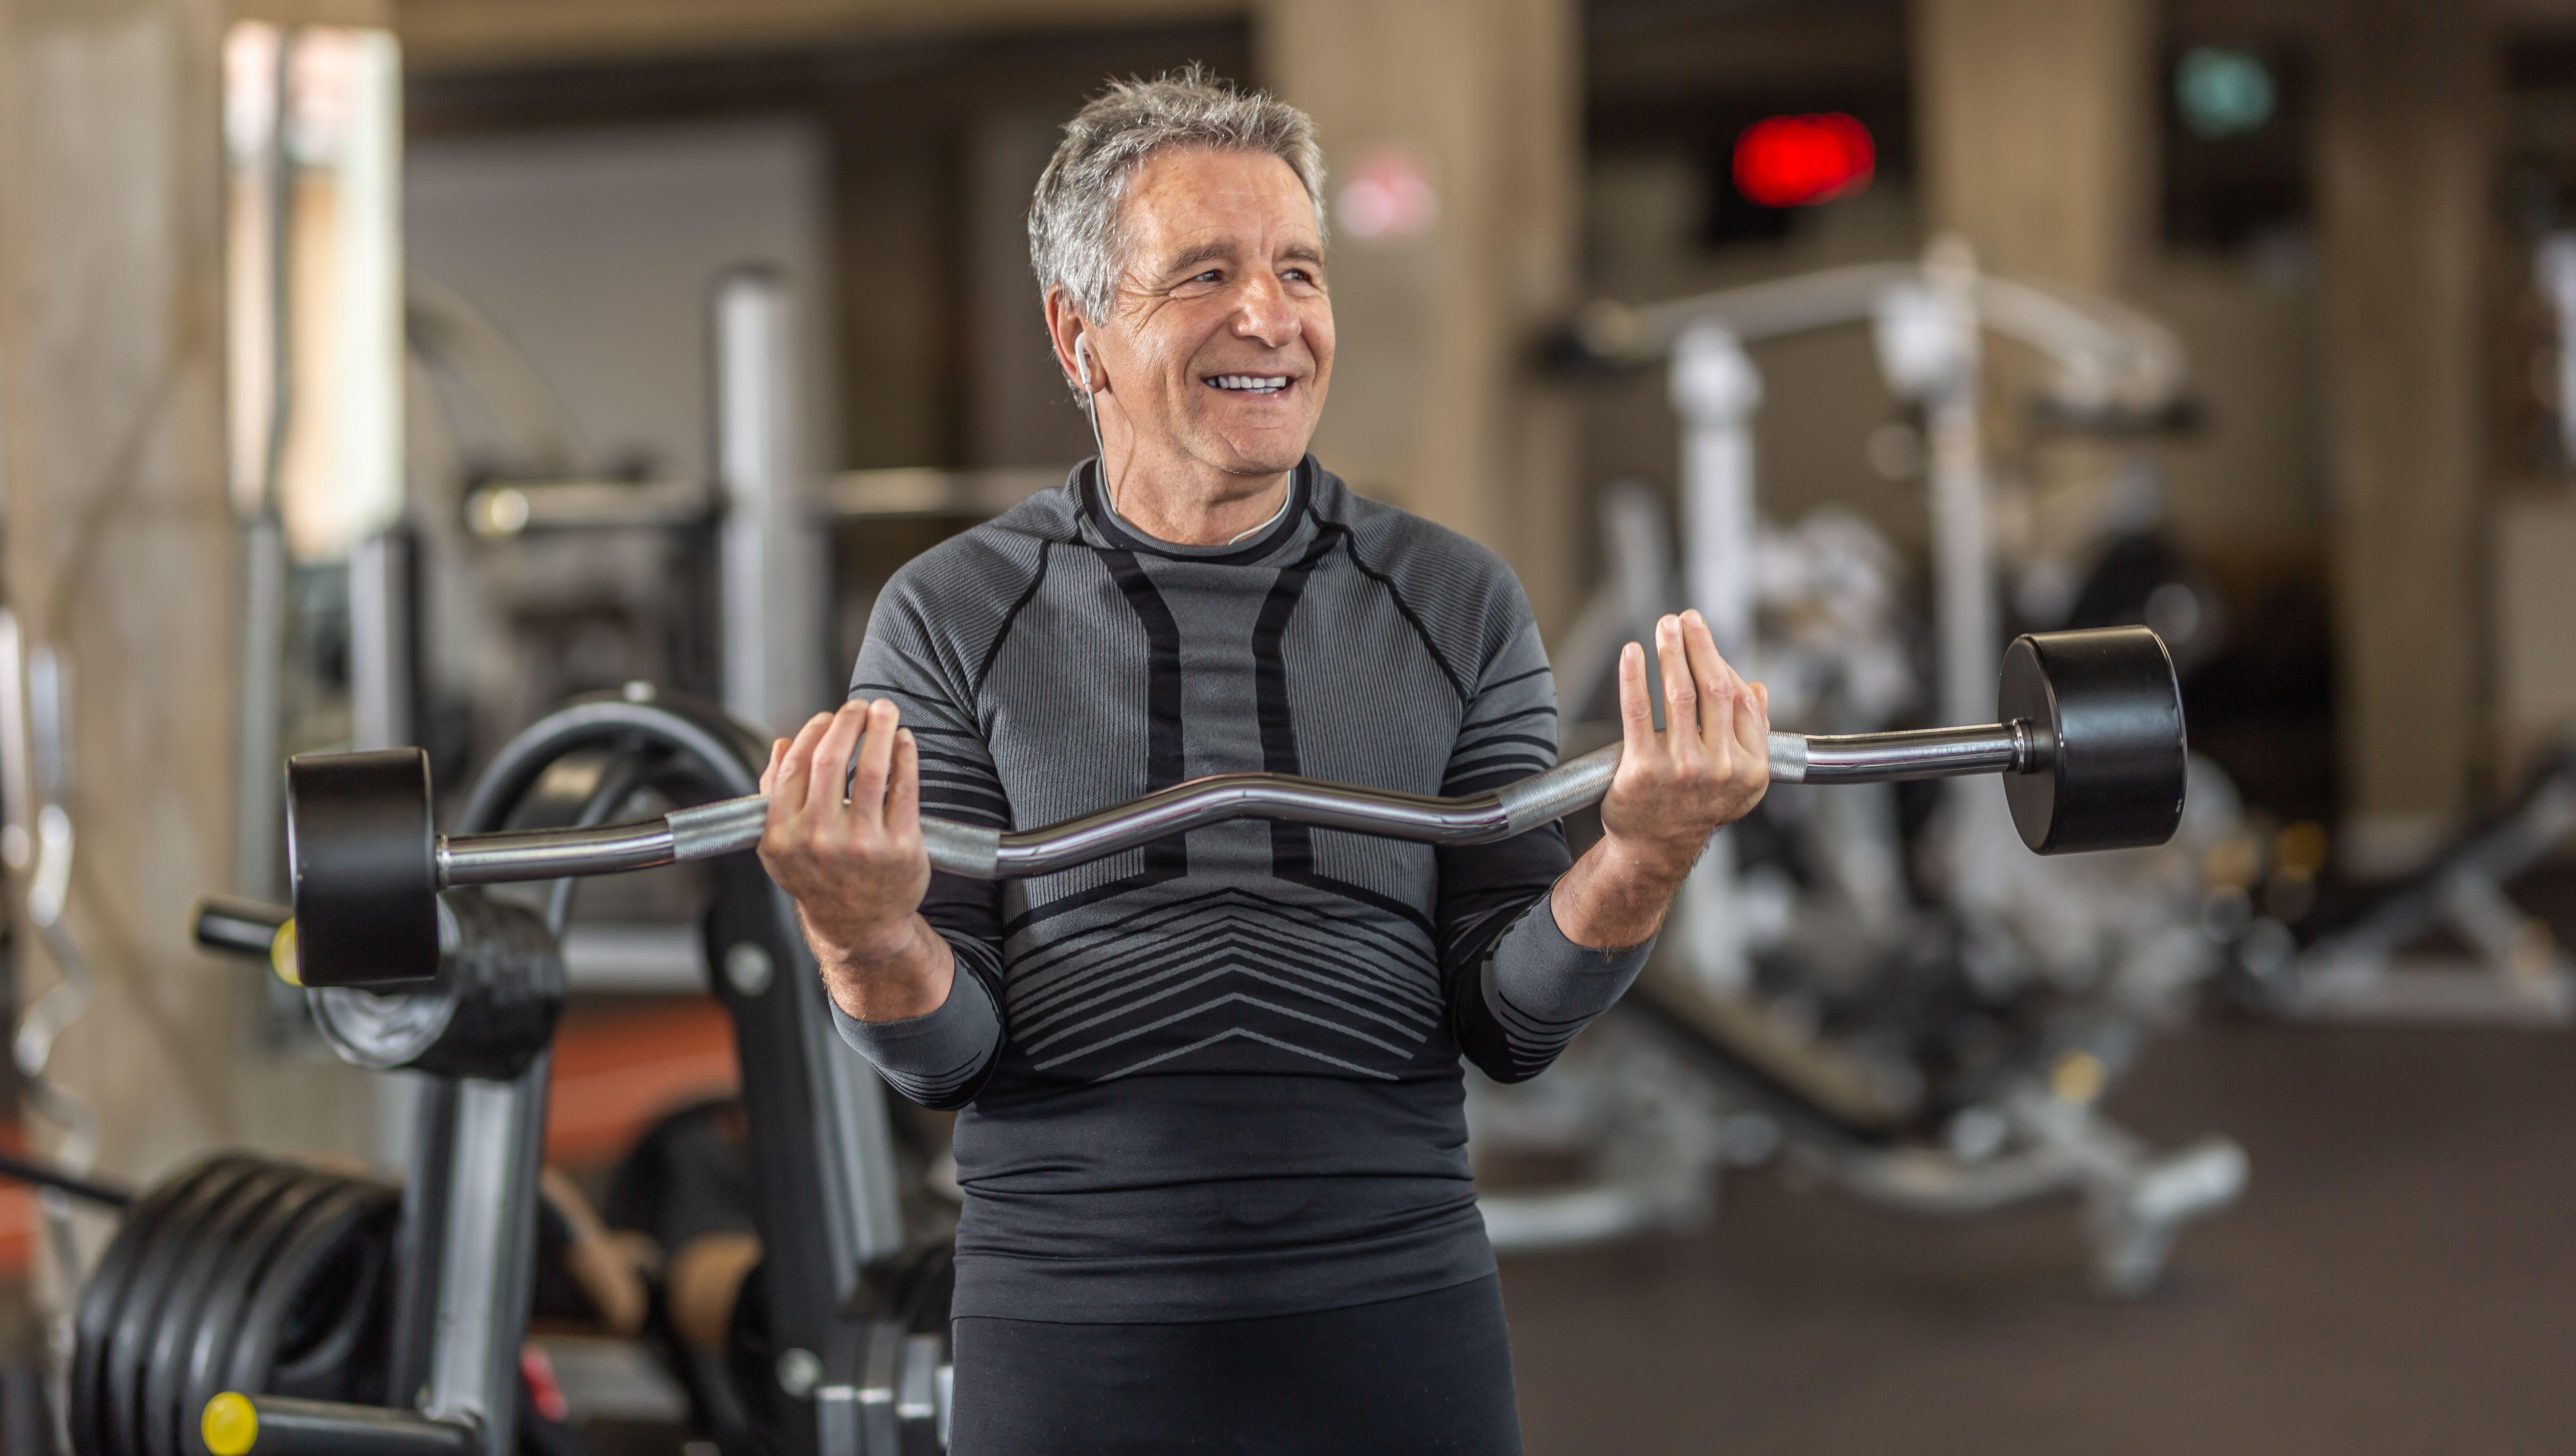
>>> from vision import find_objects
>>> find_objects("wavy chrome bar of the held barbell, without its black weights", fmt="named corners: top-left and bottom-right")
top-left (438, 722), bottom-right (2048, 889)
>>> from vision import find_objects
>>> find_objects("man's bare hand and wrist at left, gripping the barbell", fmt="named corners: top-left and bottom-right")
top-left (760, 698), bottom-right (953, 1020)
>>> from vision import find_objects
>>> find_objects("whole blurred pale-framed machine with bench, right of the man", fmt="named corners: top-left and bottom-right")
top-left (1471, 242), bottom-right (2246, 1294)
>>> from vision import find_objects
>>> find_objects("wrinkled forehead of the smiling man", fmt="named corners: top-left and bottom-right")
top-left (1118, 147), bottom-right (1322, 271)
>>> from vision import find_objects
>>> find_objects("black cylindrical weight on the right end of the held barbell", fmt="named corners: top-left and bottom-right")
top-left (1996, 626), bottom-right (2190, 855)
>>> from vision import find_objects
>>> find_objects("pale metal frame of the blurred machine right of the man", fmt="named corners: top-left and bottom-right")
top-left (1479, 242), bottom-right (2246, 1294)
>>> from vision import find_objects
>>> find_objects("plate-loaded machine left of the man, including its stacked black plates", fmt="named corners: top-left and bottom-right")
top-left (121, 688), bottom-right (948, 1456)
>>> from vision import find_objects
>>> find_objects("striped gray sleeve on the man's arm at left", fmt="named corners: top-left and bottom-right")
top-left (832, 562), bottom-right (1013, 1108)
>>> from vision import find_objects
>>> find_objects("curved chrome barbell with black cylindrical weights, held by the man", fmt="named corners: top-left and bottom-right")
top-left (281, 626), bottom-right (2184, 987)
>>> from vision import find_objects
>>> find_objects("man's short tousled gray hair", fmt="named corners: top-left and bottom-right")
top-left (1028, 62), bottom-right (1324, 322)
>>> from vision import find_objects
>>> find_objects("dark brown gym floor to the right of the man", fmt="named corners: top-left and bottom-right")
top-left (1504, 1023), bottom-right (2576, 1456)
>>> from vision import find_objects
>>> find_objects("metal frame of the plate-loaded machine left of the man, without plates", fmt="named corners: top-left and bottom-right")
top-left (138, 690), bottom-right (945, 1456)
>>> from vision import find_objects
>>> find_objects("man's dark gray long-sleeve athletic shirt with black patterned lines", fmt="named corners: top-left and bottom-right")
top-left (835, 459), bottom-right (1646, 1322)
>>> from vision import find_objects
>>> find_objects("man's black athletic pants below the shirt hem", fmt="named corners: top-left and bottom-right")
top-left (948, 1276), bottom-right (1520, 1456)
